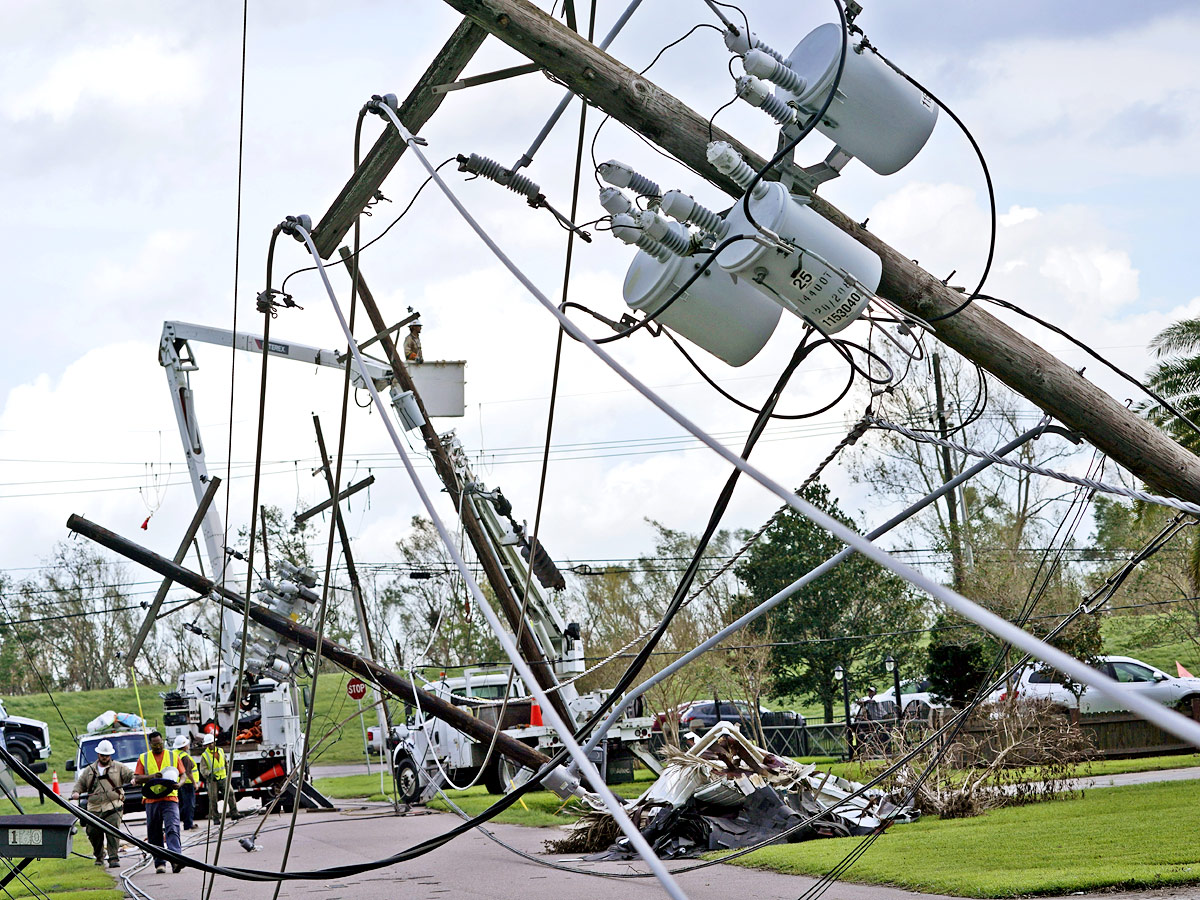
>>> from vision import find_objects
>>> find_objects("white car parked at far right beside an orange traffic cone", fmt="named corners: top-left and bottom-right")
top-left (988, 656), bottom-right (1200, 714)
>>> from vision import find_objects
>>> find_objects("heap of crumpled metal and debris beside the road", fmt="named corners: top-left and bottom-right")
top-left (546, 722), bottom-right (919, 860)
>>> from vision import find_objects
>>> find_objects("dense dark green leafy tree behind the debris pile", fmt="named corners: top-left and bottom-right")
top-left (737, 482), bottom-right (922, 719)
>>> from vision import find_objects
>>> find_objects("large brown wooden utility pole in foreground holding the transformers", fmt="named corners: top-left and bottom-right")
top-left (422, 0), bottom-right (1200, 503)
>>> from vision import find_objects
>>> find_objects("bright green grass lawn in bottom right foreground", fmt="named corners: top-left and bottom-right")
top-left (737, 781), bottom-right (1200, 898)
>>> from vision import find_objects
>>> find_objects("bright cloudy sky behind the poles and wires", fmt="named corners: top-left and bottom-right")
top-left (0, 0), bottom-right (1200, 607)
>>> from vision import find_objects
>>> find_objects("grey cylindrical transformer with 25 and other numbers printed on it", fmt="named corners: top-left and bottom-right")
top-left (710, 181), bottom-right (883, 334)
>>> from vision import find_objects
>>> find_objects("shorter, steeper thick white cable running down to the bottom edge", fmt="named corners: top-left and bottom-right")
top-left (292, 222), bottom-right (688, 900)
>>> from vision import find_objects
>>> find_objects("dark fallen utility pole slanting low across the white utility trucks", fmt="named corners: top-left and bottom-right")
top-left (67, 515), bottom-right (550, 770)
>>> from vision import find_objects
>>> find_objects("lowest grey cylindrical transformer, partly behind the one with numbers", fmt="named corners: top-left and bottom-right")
top-left (623, 251), bottom-right (780, 366)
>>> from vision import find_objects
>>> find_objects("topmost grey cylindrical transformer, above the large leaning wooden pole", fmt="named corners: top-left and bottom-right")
top-left (775, 23), bottom-right (937, 175)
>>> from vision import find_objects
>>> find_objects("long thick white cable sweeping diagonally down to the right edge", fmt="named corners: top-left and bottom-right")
top-left (364, 102), bottom-right (1200, 748)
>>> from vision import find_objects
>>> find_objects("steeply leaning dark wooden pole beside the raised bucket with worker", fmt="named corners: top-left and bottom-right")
top-left (340, 250), bottom-right (575, 722)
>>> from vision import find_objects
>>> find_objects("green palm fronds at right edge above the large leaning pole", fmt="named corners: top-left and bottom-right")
top-left (1139, 318), bottom-right (1200, 454)
